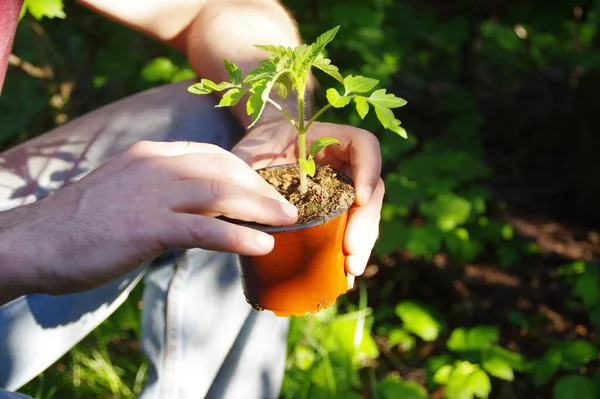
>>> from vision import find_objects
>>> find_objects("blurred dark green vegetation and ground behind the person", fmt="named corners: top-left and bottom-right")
top-left (0, 0), bottom-right (600, 399)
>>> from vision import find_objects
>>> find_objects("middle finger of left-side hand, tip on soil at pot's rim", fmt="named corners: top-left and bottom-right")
top-left (163, 179), bottom-right (298, 226)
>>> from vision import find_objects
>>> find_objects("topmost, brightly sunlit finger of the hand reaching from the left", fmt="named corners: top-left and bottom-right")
top-left (155, 152), bottom-right (287, 203)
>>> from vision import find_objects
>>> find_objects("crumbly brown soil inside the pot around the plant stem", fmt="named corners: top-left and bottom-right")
top-left (258, 165), bottom-right (355, 224)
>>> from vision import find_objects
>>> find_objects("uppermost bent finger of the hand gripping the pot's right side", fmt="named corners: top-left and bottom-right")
top-left (311, 123), bottom-right (381, 205)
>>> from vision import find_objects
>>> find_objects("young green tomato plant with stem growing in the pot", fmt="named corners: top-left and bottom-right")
top-left (188, 26), bottom-right (406, 193)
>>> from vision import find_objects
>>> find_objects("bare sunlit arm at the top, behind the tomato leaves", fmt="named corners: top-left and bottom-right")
top-left (79, 0), bottom-right (301, 126)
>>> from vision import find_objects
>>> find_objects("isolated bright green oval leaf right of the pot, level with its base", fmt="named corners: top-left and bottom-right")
top-left (396, 301), bottom-right (442, 342)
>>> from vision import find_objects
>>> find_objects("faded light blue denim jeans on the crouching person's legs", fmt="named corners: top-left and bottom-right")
top-left (0, 82), bottom-right (288, 399)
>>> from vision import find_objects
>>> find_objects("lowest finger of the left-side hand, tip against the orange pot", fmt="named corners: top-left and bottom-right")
top-left (159, 213), bottom-right (274, 256)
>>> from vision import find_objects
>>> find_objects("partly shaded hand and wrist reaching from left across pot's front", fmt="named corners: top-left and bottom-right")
top-left (0, 142), bottom-right (297, 294)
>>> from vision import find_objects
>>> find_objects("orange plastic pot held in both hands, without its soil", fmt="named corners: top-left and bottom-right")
top-left (239, 165), bottom-right (352, 316)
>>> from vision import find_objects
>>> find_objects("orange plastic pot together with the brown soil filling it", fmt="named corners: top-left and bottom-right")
top-left (240, 165), bottom-right (355, 316)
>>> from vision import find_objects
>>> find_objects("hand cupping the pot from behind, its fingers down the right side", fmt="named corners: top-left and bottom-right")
top-left (232, 119), bottom-right (384, 287)
